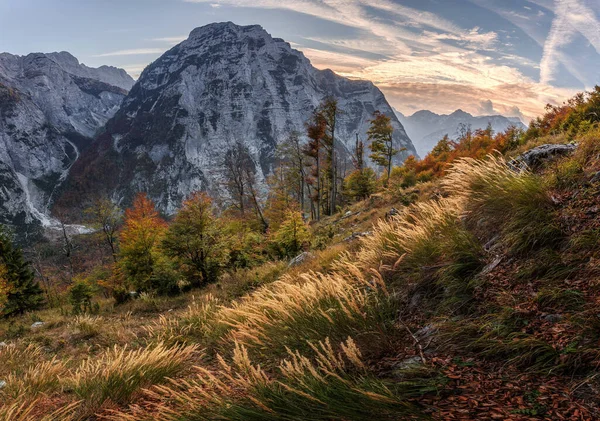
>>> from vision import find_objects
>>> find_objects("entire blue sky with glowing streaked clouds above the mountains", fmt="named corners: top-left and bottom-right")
top-left (0, 0), bottom-right (600, 122)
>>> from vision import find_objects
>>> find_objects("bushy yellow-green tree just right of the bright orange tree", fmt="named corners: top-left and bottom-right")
top-left (162, 192), bottom-right (226, 287)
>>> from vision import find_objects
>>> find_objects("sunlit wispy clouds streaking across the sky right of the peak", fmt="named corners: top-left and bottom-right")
top-left (183, 0), bottom-right (600, 117)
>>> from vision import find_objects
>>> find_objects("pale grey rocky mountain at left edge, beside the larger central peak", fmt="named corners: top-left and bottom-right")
top-left (0, 52), bottom-right (134, 236)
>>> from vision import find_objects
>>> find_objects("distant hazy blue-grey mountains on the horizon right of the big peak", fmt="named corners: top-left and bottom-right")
top-left (396, 110), bottom-right (526, 156)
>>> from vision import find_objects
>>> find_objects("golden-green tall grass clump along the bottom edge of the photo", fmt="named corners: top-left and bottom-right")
top-left (114, 338), bottom-right (435, 421)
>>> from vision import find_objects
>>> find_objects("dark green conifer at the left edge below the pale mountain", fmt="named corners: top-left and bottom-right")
top-left (0, 229), bottom-right (44, 317)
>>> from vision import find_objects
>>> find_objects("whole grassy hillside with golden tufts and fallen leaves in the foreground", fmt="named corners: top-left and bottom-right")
top-left (0, 133), bottom-right (600, 420)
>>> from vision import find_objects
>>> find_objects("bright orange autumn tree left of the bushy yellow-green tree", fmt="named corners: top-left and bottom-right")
top-left (117, 193), bottom-right (167, 291)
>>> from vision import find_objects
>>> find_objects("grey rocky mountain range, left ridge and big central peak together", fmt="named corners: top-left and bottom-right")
top-left (0, 22), bottom-right (416, 233)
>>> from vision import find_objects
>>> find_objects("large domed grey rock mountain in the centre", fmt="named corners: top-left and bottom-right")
top-left (59, 22), bottom-right (416, 213)
